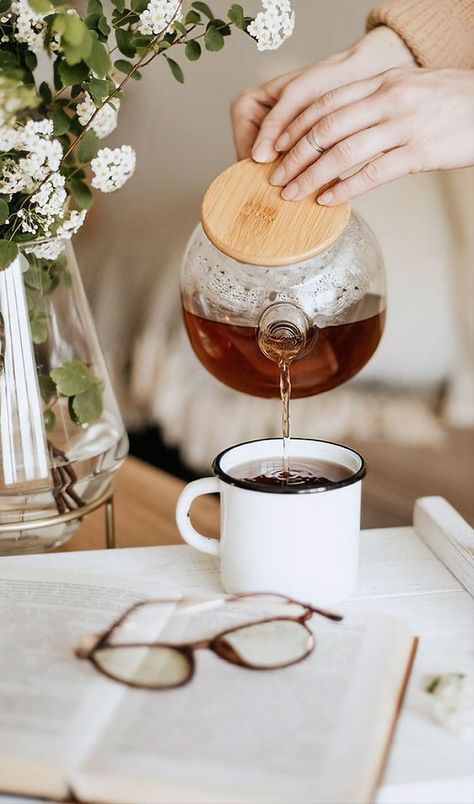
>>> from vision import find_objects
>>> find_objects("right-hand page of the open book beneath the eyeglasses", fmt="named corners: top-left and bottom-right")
top-left (71, 612), bottom-right (412, 804)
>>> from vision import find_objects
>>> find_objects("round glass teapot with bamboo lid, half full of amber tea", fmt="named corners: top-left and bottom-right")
top-left (181, 160), bottom-right (385, 398)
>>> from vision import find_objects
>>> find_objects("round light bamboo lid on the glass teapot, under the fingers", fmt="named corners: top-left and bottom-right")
top-left (201, 159), bottom-right (351, 267)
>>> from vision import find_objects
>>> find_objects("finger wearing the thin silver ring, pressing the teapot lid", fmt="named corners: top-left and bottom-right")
top-left (270, 96), bottom-right (384, 187)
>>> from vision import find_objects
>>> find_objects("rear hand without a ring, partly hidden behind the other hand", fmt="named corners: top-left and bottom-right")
top-left (231, 26), bottom-right (415, 162)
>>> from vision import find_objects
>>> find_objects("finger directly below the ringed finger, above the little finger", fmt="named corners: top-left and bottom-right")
top-left (282, 123), bottom-right (400, 201)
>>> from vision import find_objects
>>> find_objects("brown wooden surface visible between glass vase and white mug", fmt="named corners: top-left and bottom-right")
top-left (65, 456), bottom-right (219, 550)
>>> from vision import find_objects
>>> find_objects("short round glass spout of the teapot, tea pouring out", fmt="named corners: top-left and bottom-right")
top-left (256, 302), bottom-right (317, 366)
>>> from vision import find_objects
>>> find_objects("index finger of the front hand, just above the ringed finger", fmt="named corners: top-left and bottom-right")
top-left (275, 76), bottom-right (382, 151)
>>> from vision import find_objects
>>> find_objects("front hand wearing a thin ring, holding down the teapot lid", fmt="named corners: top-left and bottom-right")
top-left (270, 68), bottom-right (474, 204)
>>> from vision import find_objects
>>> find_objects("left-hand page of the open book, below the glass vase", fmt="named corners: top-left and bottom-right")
top-left (0, 565), bottom-right (175, 798)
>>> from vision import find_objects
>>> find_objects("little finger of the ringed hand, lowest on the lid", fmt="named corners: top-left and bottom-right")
top-left (318, 147), bottom-right (412, 205)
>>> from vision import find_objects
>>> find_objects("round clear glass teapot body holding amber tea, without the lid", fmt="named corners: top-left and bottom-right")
top-left (181, 207), bottom-right (385, 398)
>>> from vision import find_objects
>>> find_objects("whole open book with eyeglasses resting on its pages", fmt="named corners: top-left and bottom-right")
top-left (0, 548), bottom-right (415, 804)
